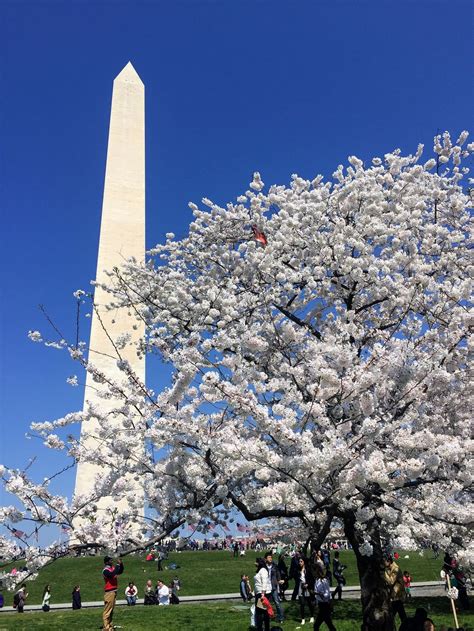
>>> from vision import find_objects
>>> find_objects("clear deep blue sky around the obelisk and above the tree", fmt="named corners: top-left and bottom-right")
top-left (0, 0), bottom-right (473, 504)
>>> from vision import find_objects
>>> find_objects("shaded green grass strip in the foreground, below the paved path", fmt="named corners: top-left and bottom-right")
top-left (0, 598), bottom-right (474, 631)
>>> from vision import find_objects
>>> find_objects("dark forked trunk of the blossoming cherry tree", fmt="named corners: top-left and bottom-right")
top-left (344, 515), bottom-right (395, 631)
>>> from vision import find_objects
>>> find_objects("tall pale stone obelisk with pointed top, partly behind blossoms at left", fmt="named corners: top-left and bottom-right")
top-left (75, 62), bottom-right (145, 521)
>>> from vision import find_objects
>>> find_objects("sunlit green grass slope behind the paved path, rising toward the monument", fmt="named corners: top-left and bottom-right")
top-left (0, 551), bottom-right (442, 605)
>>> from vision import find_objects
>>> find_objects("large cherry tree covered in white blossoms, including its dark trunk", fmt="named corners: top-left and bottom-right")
top-left (3, 132), bottom-right (474, 631)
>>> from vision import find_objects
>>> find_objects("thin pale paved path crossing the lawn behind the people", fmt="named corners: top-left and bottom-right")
top-left (0, 581), bottom-right (445, 615)
